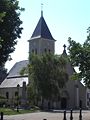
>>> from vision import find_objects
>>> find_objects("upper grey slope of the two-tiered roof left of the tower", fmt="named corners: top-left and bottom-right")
top-left (7, 60), bottom-right (28, 78)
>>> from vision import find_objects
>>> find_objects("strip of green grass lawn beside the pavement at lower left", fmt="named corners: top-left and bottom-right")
top-left (0, 108), bottom-right (37, 115)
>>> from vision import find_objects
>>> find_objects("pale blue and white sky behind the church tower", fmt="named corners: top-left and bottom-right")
top-left (6, 0), bottom-right (90, 70)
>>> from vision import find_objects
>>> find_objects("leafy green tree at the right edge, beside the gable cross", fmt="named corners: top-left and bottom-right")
top-left (68, 32), bottom-right (90, 88)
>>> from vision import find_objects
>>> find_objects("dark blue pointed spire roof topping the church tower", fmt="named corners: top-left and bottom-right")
top-left (31, 11), bottom-right (55, 40)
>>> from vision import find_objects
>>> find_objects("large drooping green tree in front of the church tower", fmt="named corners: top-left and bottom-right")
top-left (28, 54), bottom-right (68, 105)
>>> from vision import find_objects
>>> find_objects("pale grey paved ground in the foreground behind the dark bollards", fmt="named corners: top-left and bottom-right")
top-left (4, 111), bottom-right (90, 120)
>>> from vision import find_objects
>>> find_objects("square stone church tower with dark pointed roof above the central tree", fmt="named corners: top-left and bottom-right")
top-left (29, 10), bottom-right (55, 55)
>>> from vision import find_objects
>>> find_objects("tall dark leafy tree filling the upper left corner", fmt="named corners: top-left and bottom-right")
top-left (0, 0), bottom-right (23, 67)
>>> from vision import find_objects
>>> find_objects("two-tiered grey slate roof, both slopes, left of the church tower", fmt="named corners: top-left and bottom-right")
top-left (0, 60), bottom-right (28, 88)
